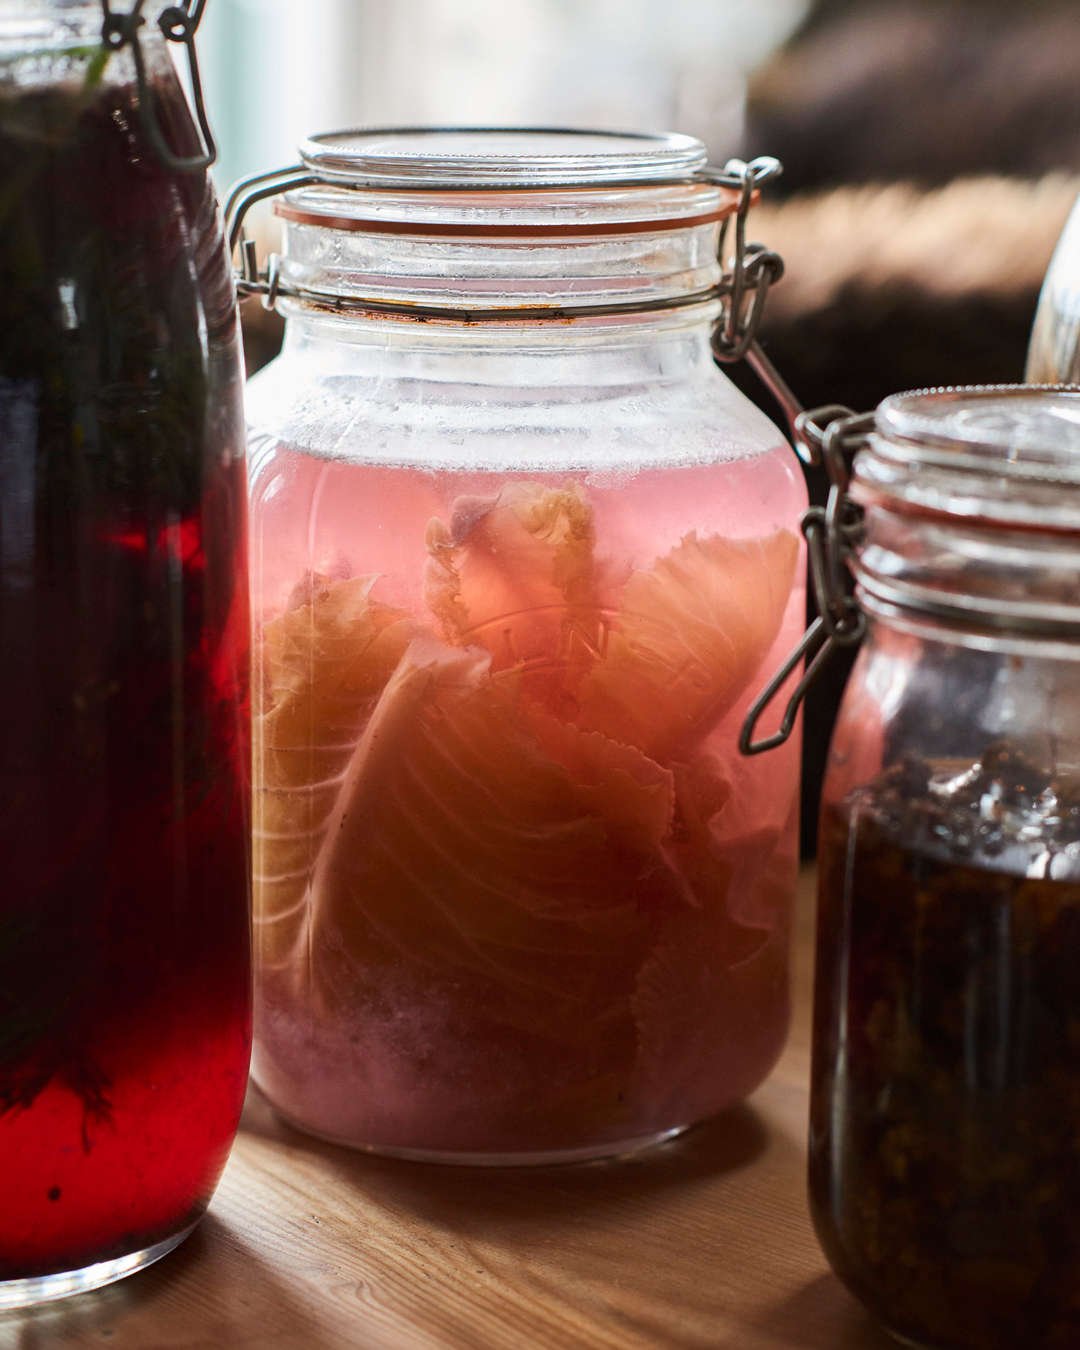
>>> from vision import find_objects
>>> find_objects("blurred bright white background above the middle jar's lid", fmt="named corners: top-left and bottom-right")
top-left (200, 0), bottom-right (807, 190)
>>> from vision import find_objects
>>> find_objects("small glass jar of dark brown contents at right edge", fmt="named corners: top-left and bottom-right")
top-left (810, 386), bottom-right (1080, 1350)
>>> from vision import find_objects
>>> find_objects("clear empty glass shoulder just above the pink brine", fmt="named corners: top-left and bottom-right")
top-left (247, 333), bottom-right (783, 471)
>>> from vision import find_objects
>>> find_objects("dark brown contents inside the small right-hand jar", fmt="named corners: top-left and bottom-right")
top-left (810, 741), bottom-right (1080, 1350)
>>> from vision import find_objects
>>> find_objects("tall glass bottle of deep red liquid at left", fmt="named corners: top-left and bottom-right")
top-left (0, 3), bottom-right (250, 1307)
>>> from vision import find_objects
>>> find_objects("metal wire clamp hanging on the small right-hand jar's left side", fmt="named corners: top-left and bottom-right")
top-left (738, 404), bottom-right (873, 755)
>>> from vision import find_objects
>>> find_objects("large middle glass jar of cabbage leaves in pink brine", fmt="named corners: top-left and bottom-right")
top-left (247, 132), bottom-right (805, 1161)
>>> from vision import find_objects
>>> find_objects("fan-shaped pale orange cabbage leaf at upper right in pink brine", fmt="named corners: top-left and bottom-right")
top-left (578, 529), bottom-right (798, 763)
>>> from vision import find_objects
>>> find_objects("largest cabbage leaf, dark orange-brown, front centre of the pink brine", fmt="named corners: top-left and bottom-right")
top-left (312, 641), bottom-right (686, 1046)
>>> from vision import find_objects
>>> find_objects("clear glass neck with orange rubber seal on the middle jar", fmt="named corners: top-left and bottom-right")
top-left (275, 182), bottom-right (732, 319)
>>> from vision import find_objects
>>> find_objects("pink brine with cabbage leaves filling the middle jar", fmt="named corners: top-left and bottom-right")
top-left (252, 448), bottom-right (805, 1158)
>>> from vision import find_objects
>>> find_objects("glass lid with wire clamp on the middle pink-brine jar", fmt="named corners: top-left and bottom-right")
top-left (227, 127), bottom-right (798, 372)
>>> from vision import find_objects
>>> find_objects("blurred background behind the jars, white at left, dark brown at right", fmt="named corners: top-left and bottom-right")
top-left (209, 0), bottom-right (1080, 851)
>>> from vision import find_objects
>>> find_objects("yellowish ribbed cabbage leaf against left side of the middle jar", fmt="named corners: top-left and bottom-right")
top-left (252, 576), bottom-right (423, 967)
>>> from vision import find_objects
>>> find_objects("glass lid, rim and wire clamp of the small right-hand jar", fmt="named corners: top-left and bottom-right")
top-left (740, 385), bottom-right (1080, 755)
